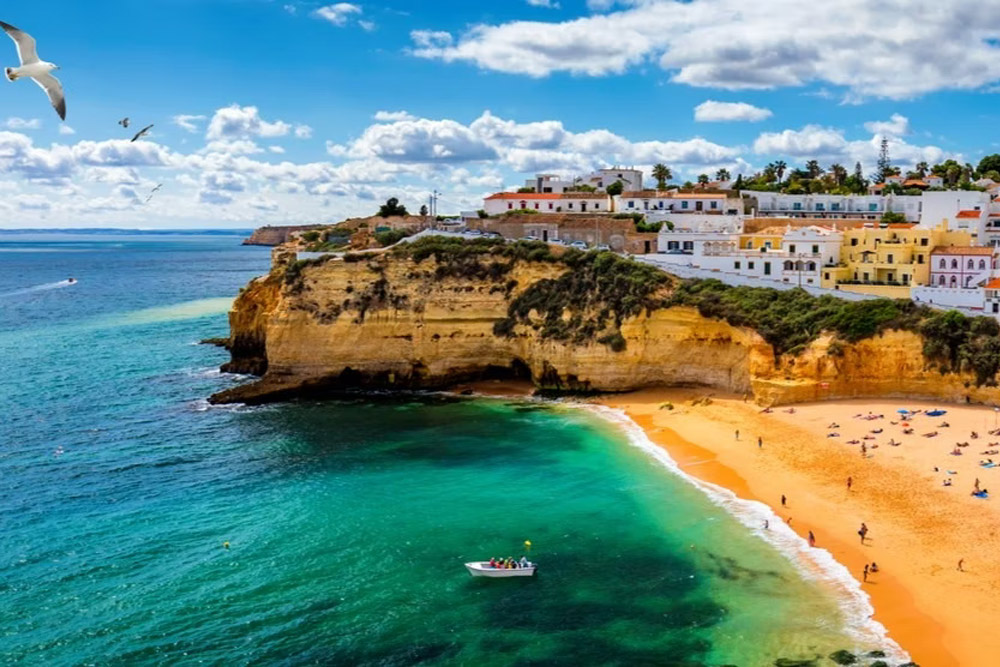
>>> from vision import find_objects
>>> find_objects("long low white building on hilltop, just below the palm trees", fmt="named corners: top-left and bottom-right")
top-left (752, 190), bottom-right (921, 222)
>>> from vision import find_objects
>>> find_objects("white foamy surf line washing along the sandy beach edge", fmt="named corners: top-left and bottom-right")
top-left (582, 405), bottom-right (910, 663)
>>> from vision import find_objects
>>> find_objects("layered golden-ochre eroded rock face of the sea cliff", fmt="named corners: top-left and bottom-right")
top-left (212, 257), bottom-right (997, 404)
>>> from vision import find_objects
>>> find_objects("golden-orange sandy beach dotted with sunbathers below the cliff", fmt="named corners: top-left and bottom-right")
top-left (598, 389), bottom-right (1000, 666)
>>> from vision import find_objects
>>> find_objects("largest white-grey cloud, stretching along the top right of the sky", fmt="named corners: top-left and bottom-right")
top-left (411, 0), bottom-right (1000, 99)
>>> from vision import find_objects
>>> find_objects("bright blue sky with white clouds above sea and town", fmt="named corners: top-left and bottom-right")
top-left (0, 0), bottom-right (1000, 228)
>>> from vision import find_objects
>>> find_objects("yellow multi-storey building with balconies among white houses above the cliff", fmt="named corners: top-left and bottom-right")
top-left (820, 223), bottom-right (972, 298)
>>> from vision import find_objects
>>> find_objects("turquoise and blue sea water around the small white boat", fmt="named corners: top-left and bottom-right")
top-left (0, 235), bottom-right (900, 665)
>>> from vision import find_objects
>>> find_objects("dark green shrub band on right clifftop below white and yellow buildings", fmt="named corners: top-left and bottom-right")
top-left (666, 280), bottom-right (1000, 386)
